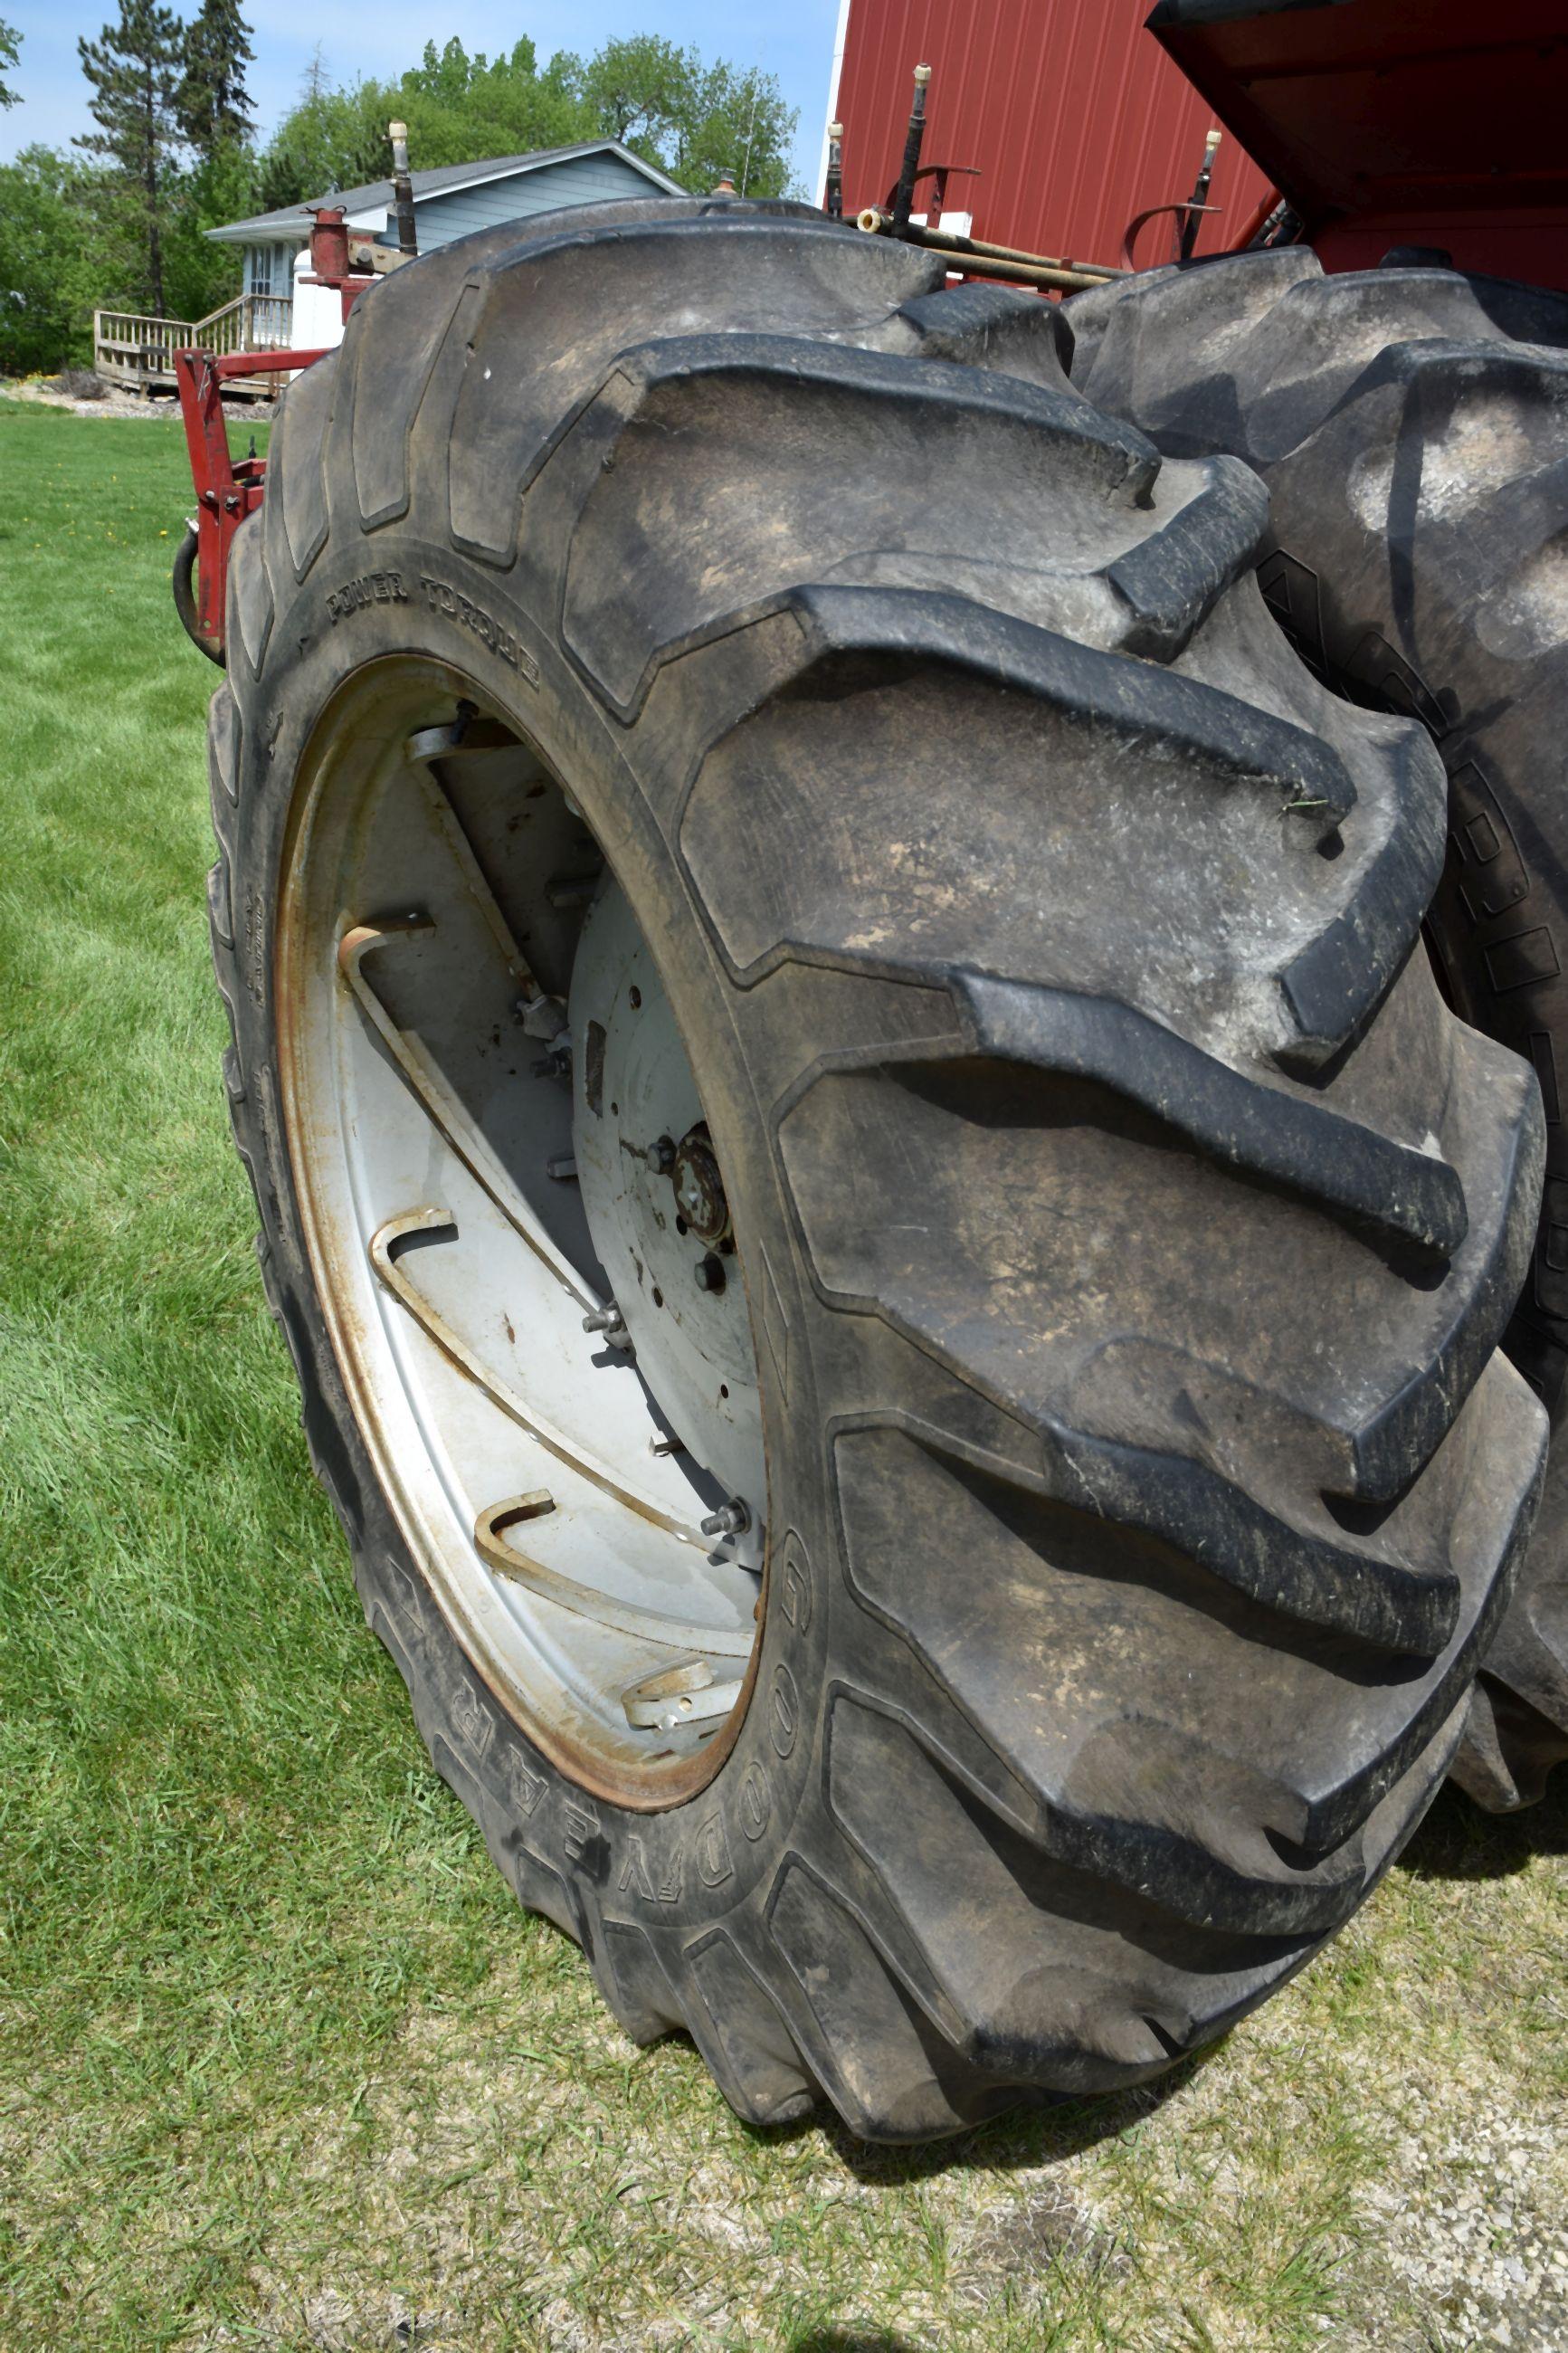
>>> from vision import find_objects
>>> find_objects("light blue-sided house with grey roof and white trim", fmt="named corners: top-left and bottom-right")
top-left (207, 138), bottom-right (687, 329)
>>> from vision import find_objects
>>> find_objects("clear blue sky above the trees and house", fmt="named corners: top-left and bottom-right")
top-left (0, 0), bottom-right (837, 188)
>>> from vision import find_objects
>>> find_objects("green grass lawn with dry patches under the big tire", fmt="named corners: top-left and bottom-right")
top-left (0, 403), bottom-right (1568, 2353)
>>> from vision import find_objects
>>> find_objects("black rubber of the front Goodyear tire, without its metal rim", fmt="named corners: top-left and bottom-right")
top-left (209, 200), bottom-right (1544, 2139)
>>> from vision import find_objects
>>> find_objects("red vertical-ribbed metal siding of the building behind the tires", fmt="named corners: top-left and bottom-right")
top-left (837, 0), bottom-right (1265, 263)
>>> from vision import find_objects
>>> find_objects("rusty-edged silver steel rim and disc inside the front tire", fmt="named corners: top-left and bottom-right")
top-left (280, 694), bottom-right (766, 1805)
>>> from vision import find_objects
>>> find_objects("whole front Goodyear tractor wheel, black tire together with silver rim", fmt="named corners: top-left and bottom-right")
top-left (212, 200), bottom-right (1544, 2139)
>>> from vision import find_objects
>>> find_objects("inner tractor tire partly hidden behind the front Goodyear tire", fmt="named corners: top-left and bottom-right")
top-left (1068, 250), bottom-right (1568, 1812)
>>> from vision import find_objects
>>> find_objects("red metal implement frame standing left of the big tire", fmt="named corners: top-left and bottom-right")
top-left (174, 207), bottom-right (376, 663)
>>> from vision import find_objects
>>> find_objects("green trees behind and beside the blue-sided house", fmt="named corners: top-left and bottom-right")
top-left (0, 18), bottom-right (794, 372)
